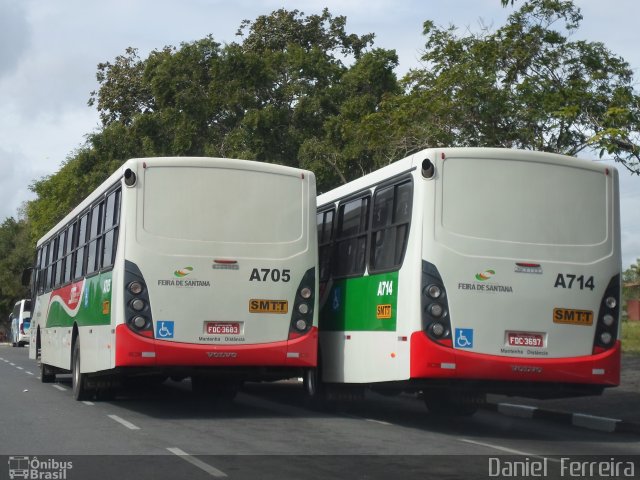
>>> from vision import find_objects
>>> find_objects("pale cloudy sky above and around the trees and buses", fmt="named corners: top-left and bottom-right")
top-left (0, 0), bottom-right (640, 268)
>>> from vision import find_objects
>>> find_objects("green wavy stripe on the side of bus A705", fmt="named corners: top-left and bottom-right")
top-left (47, 272), bottom-right (111, 327)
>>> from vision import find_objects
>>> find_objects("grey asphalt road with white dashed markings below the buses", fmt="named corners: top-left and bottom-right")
top-left (0, 345), bottom-right (640, 480)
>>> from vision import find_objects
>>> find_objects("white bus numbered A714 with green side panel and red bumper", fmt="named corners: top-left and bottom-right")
top-left (316, 148), bottom-right (621, 414)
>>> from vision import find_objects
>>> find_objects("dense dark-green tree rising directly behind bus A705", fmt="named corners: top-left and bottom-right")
top-left (79, 9), bottom-right (401, 187)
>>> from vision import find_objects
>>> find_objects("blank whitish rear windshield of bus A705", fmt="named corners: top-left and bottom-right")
top-left (143, 166), bottom-right (304, 243)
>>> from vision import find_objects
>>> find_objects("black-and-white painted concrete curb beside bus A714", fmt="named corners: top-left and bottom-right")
top-left (485, 403), bottom-right (640, 435)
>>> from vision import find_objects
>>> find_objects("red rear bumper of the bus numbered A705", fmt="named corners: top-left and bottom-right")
top-left (116, 325), bottom-right (318, 367)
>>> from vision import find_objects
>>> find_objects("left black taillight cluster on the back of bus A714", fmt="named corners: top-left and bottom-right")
top-left (421, 261), bottom-right (452, 347)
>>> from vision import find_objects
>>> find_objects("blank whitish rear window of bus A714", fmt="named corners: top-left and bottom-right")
top-left (441, 158), bottom-right (608, 246)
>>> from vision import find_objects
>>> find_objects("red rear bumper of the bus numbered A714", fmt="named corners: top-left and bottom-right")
top-left (411, 332), bottom-right (621, 386)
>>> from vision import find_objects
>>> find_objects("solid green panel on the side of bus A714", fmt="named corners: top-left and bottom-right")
top-left (320, 272), bottom-right (398, 332)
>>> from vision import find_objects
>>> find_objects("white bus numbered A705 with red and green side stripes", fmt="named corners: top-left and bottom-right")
top-left (29, 157), bottom-right (317, 399)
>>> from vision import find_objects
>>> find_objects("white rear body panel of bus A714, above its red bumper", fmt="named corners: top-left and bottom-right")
top-left (432, 149), bottom-right (621, 358)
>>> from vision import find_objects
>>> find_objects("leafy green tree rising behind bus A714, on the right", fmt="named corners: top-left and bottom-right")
top-left (370, 0), bottom-right (640, 174)
